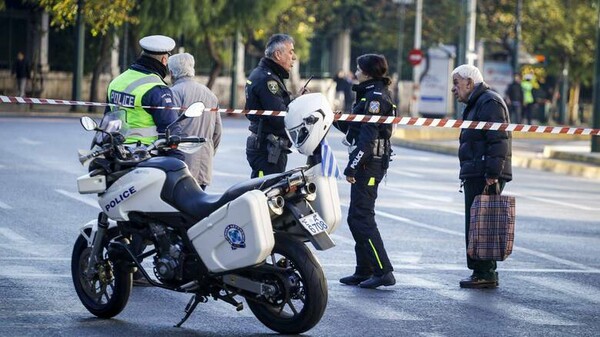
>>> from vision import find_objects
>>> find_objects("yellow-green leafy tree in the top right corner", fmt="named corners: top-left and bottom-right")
top-left (478, 0), bottom-right (598, 122)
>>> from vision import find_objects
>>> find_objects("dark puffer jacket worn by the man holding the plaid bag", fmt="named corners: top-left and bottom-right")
top-left (458, 83), bottom-right (512, 181)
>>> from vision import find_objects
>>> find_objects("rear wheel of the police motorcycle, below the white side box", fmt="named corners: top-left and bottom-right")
top-left (248, 233), bottom-right (327, 334)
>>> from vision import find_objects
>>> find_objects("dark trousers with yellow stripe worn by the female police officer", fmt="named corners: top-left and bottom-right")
top-left (348, 160), bottom-right (394, 276)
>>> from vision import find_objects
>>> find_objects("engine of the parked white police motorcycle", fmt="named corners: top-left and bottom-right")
top-left (150, 224), bottom-right (185, 283)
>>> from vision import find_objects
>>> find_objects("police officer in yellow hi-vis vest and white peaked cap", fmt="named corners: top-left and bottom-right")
top-left (108, 35), bottom-right (183, 159)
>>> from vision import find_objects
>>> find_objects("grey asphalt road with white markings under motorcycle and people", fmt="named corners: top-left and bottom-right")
top-left (0, 117), bottom-right (600, 337)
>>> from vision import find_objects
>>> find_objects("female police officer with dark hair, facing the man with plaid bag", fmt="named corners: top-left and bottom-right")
top-left (336, 54), bottom-right (396, 288)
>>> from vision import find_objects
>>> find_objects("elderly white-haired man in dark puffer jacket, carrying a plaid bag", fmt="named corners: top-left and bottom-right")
top-left (452, 64), bottom-right (512, 288)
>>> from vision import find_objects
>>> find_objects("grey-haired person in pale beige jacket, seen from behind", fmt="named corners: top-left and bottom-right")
top-left (168, 53), bottom-right (222, 189)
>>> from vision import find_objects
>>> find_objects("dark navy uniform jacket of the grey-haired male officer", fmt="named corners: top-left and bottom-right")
top-left (244, 58), bottom-right (291, 138)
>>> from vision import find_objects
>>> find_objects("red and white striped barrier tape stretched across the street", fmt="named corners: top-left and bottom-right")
top-left (0, 95), bottom-right (600, 136)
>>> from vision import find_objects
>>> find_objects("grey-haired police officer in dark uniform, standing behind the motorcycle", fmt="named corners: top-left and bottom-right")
top-left (244, 34), bottom-right (304, 178)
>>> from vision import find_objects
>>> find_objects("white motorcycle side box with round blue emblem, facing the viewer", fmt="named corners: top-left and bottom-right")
top-left (188, 190), bottom-right (275, 273)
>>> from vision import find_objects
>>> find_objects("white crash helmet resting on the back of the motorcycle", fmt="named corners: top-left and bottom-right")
top-left (284, 93), bottom-right (333, 156)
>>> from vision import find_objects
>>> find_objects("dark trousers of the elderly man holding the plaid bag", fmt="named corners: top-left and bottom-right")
top-left (463, 178), bottom-right (506, 279)
